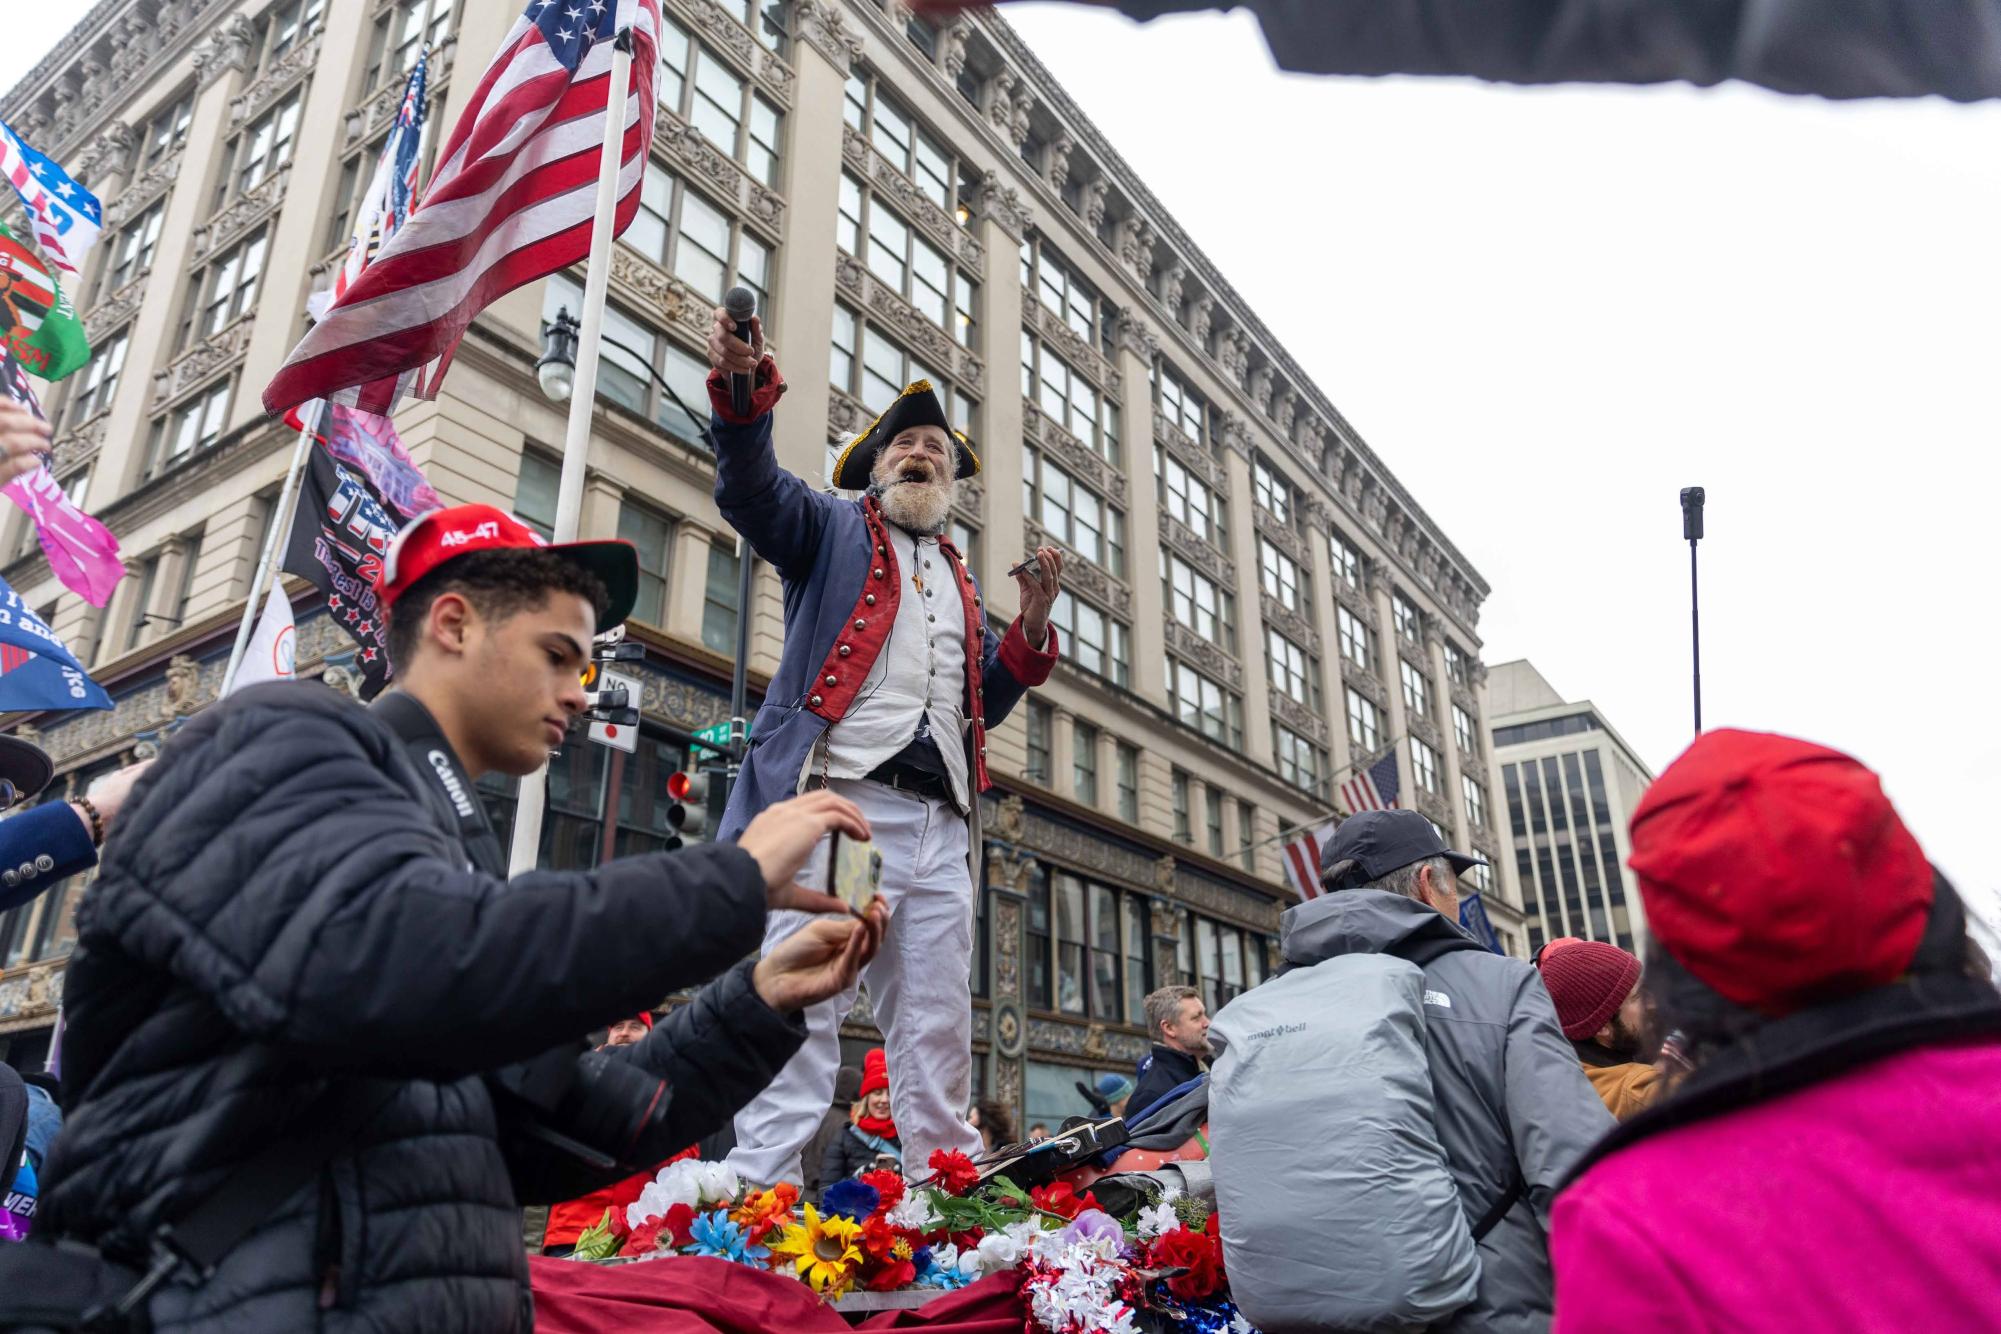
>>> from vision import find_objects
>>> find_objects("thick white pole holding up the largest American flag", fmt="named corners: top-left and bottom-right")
top-left (508, 28), bottom-right (632, 876)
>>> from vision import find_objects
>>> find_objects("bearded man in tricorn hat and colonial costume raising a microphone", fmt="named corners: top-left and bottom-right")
top-left (708, 310), bottom-right (1063, 1184)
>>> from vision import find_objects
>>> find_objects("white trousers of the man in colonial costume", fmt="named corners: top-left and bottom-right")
top-left (728, 778), bottom-right (980, 1186)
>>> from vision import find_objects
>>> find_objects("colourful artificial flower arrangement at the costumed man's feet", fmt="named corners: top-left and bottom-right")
top-left (574, 1150), bottom-right (1255, 1334)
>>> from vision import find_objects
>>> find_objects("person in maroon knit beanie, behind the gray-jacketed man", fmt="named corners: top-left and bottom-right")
top-left (1535, 938), bottom-right (1661, 1120)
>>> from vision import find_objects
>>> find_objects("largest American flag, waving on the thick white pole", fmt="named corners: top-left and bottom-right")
top-left (264, 0), bottom-right (660, 416)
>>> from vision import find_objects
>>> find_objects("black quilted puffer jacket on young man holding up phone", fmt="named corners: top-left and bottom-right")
top-left (44, 684), bottom-right (804, 1334)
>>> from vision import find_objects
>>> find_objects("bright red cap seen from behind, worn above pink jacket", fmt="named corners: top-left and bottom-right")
top-left (1627, 730), bottom-right (1933, 1014)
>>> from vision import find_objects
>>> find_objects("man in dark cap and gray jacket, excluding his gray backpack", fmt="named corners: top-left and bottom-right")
top-left (1281, 810), bottom-right (1615, 1332)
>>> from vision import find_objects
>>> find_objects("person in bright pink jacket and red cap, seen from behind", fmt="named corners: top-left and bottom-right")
top-left (1551, 730), bottom-right (2001, 1334)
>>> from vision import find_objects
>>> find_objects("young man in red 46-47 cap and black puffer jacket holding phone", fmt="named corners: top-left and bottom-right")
top-left (31, 506), bottom-right (876, 1334)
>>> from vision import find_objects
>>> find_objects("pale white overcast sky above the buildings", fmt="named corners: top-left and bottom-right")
top-left (0, 13), bottom-right (2001, 908)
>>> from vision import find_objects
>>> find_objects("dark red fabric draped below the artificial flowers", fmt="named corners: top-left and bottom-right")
top-left (528, 1256), bottom-right (1027, 1334)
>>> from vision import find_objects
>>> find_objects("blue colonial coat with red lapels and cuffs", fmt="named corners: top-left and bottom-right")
top-left (708, 376), bottom-right (1057, 838)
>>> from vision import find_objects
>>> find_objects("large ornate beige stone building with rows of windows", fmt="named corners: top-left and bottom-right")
top-left (0, 0), bottom-right (1523, 1118)
